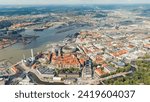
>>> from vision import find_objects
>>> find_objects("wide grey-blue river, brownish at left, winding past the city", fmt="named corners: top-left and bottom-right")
top-left (0, 27), bottom-right (86, 63)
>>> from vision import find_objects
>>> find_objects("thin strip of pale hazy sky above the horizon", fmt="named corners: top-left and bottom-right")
top-left (0, 0), bottom-right (150, 4)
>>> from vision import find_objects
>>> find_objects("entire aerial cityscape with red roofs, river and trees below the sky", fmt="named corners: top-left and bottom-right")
top-left (0, 0), bottom-right (150, 85)
